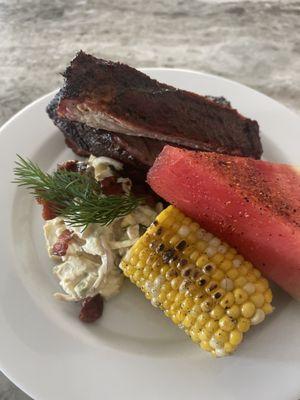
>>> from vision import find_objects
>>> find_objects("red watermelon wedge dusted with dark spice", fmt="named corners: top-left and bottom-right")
top-left (148, 146), bottom-right (300, 299)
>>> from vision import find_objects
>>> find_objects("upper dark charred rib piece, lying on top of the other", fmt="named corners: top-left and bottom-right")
top-left (51, 52), bottom-right (262, 158)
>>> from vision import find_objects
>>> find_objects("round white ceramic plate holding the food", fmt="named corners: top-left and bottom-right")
top-left (0, 69), bottom-right (300, 400)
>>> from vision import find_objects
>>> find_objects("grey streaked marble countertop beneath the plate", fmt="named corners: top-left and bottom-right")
top-left (0, 0), bottom-right (300, 400)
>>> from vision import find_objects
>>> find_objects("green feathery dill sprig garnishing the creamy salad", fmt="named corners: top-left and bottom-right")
top-left (13, 155), bottom-right (142, 228)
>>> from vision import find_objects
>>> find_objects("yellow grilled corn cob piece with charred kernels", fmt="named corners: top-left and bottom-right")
top-left (120, 206), bottom-right (273, 356)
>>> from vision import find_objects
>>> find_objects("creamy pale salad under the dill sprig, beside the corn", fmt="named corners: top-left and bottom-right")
top-left (44, 156), bottom-right (162, 301)
